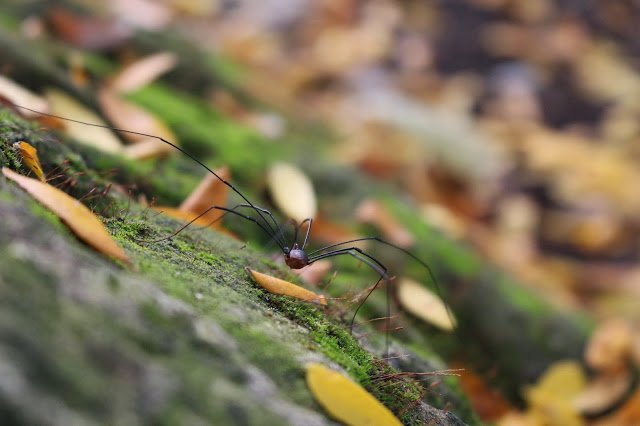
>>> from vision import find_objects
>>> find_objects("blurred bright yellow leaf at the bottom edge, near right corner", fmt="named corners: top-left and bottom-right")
top-left (525, 361), bottom-right (586, 426)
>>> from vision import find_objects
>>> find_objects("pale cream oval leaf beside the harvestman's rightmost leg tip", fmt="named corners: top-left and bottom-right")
top-left (398, 278), bottom-right (456, 331)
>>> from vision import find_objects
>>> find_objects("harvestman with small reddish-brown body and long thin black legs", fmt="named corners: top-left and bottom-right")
top-left (7, 102), bottom-right (451, 347)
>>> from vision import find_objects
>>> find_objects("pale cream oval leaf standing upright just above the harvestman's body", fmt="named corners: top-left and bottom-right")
top-left (267, 163), bottom-right (317, 222)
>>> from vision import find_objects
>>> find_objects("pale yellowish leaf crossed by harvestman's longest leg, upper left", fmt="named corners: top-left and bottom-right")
top-left (46, 89), bottom-right (122, 153)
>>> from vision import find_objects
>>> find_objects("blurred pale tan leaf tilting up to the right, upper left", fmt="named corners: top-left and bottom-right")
top-left (109, 52), bottom-right (178, 93)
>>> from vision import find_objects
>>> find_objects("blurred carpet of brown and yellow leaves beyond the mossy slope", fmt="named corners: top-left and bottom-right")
top-left (0, 0), bottom-right (640, 424)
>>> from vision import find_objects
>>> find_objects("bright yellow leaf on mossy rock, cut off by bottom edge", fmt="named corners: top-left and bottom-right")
top-left (307, 363), bottom-right (402, 426)
